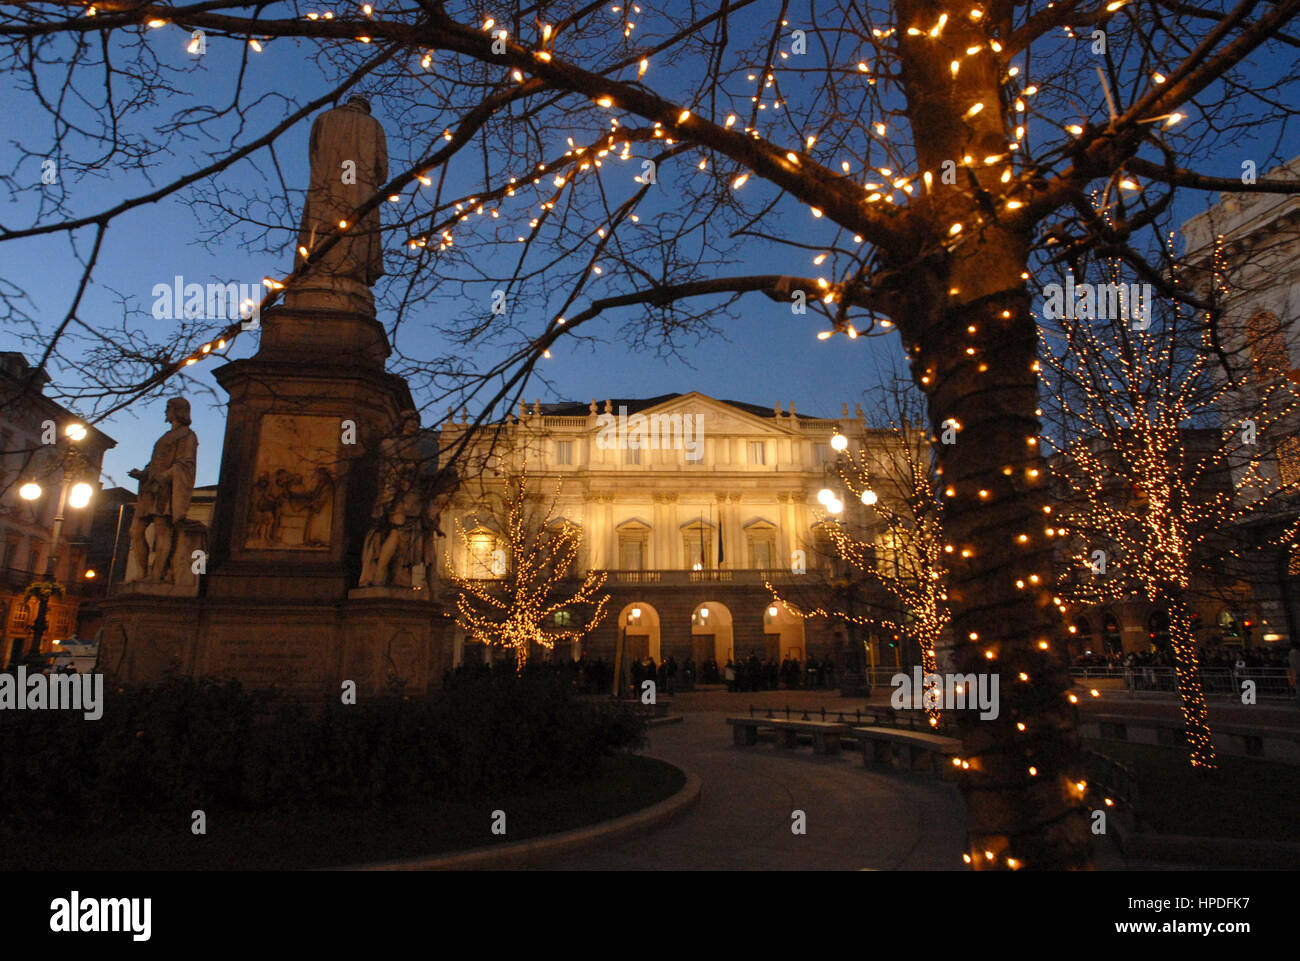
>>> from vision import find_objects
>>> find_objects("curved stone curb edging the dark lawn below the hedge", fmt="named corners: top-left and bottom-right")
top-left (335, 765), bottom-right (702, 871)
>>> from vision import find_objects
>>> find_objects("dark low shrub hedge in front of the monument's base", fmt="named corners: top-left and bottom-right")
top-left (0, 674), bottom-right (644, 832)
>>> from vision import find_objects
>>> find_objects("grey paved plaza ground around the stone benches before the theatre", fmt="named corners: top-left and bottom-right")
top-left (547, 691), bottom-right (1300, 871)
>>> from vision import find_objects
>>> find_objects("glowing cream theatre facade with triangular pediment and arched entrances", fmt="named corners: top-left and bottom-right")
top-left (439, 393), bottom-right (902, 670)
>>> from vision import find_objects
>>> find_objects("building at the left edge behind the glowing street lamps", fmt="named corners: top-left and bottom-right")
top-left (0, 351), bottom-right (117, 666)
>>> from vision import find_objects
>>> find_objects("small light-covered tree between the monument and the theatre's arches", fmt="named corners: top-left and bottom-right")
top-left (449, 471), bottom-right (610, 672)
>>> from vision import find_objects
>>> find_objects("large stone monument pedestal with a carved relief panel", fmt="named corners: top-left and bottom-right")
top-left (100, 302), bottom-right (451, 700)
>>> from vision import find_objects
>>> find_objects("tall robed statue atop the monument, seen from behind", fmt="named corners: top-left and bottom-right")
top-left (295, 96), bottom-right (389, 309)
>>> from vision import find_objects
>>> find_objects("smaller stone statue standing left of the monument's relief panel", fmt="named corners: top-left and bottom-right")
top-left (129, 397), bottom-right (199, 584)
